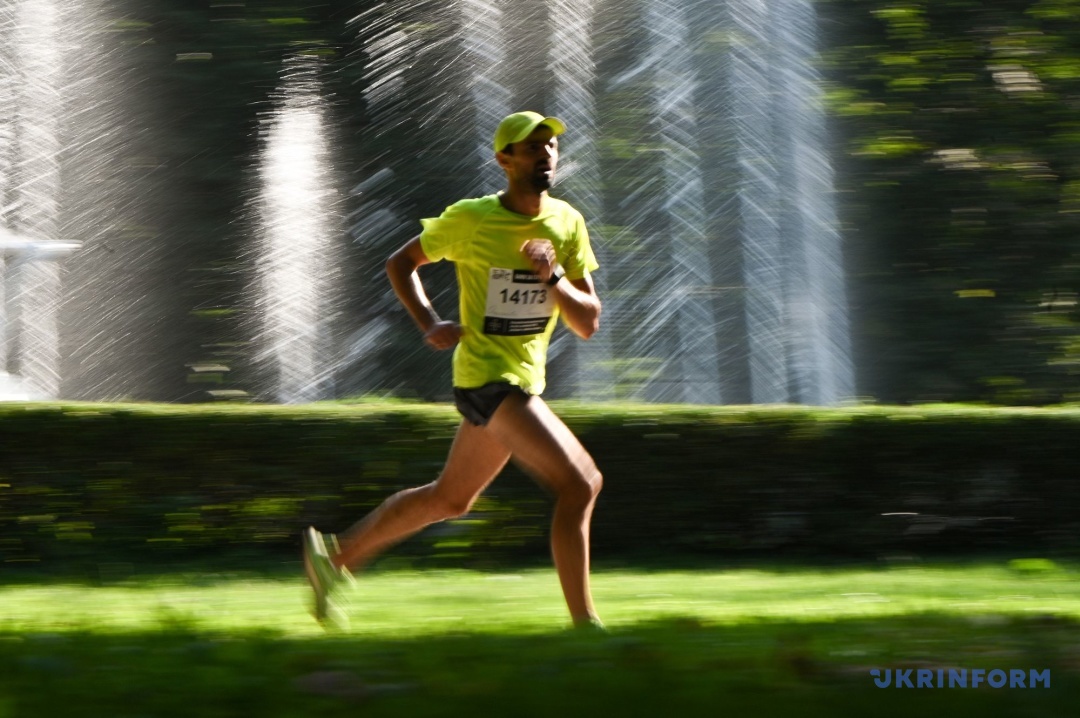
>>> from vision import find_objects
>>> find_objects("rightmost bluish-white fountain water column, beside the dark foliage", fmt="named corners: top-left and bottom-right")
top-left (727, 0), bottom-right (854, 404)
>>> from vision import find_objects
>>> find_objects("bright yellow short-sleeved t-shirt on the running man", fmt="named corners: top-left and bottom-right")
top-left (420, 194), bottom-right (598, 394)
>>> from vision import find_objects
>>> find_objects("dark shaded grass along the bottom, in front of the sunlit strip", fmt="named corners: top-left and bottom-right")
top-left (0, 614), bottom-right (1080, 718)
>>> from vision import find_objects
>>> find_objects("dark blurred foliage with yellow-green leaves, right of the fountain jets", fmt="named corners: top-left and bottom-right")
top-left (819, 0), bottom-right (1080, 404)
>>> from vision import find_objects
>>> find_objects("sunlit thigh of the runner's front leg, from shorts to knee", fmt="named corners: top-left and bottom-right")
top-left (487, 394), bottom-right (599, 488)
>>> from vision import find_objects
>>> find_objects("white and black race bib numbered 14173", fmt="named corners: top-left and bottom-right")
top-left (484, 267), bottom-right (555, 337)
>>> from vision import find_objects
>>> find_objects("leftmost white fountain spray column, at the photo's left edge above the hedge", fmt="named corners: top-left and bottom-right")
top-left (0, 0), bottom-right (81, 398)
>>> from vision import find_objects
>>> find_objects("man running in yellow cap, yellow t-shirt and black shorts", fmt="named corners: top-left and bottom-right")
top-left (303, 112), bottom-right (602, 627)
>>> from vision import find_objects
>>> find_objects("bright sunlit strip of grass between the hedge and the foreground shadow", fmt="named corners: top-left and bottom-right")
top-left (6, 563), bottom-right (1080, 638)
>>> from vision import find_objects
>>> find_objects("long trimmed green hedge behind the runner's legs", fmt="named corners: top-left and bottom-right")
top-left (0, 403), bottom-right (1080, 564)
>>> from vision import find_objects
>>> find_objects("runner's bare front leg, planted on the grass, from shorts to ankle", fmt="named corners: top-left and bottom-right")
top-left (487, 394), bottom-right (603, 625)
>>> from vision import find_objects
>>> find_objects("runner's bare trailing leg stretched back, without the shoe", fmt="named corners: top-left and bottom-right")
top-left (332, 421), bottom-right (510, 568)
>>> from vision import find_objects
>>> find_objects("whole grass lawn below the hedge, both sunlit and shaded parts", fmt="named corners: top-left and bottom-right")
top-left (0, 561), bottom-right (1080, 718)
